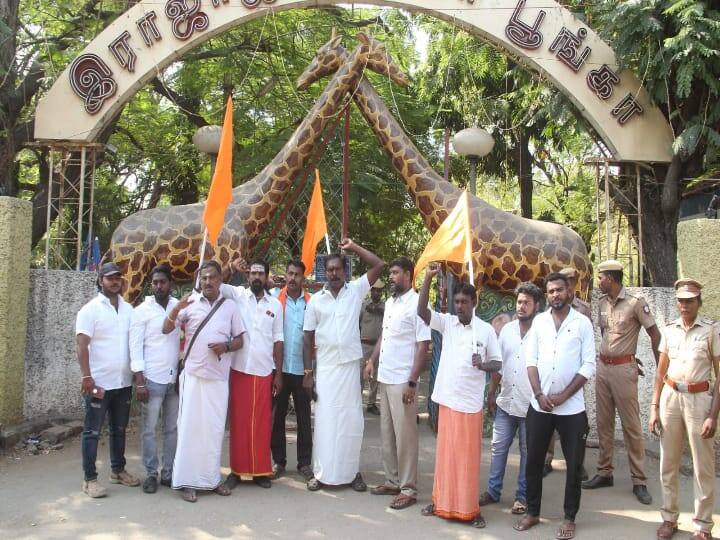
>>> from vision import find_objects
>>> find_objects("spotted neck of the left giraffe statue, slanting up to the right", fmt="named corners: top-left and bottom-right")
top-left (227, 47), bottom-right (365, 239)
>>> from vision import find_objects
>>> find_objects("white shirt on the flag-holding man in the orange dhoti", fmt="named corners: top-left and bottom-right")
top-left (430, 311), bottom-right (502, 413)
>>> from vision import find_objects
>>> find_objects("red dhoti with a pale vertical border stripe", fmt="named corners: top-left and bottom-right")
top-left (230, 369), bottom-right (272, 476)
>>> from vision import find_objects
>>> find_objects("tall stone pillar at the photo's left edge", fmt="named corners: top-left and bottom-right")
top-left (0, 197), bottom-right (32, 425)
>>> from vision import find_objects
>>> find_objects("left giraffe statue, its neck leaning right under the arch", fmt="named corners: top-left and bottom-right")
top-left (105, 31), bottom-right (407, 302)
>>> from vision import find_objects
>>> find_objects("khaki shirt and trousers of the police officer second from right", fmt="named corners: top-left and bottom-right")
top-left (595, 287), bottom-right (655, 485)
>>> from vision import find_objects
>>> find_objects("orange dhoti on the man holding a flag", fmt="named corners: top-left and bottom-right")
top-left (433, 405), bottom-right (482, 521)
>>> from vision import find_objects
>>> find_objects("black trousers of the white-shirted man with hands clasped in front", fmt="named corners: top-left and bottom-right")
top-left (525, 405), bottom-right (588, 521)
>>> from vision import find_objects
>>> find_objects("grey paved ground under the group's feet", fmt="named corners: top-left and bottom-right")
top-left (0, 410), bottom-right (720, 540)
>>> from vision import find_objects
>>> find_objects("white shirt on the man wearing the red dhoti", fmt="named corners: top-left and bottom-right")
top-left (220, 284), bottom-right (283, 377)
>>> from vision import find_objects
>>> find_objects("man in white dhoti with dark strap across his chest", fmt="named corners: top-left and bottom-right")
top-left (163, 261), bottom-right (245, 502)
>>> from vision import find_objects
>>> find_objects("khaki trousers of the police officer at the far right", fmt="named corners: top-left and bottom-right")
top-left (660, 385), bottom-right (715, 532)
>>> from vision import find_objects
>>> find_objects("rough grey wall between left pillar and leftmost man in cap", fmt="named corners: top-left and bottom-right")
top-left (23, 270), bottom-right (97, 420)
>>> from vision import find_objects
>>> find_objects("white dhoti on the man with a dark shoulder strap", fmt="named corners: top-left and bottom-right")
top-left (172, 371), bottom-right (228, 490)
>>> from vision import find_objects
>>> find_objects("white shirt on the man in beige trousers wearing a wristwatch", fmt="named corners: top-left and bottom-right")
top-left (378, 289), bottom-right (430, 384)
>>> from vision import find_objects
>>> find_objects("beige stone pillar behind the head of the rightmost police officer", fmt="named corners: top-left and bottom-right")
top-left (677, 219), bottom-right (720, 320)
